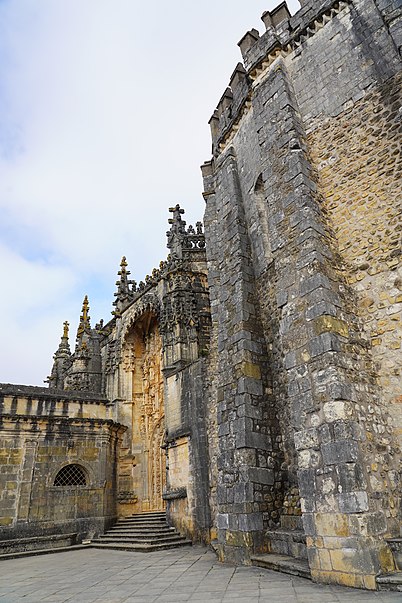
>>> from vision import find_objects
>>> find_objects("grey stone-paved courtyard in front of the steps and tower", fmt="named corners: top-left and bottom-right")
top-left (0, 546), bottom-right (402, 603)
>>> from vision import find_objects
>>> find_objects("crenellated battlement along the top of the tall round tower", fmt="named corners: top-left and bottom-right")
top-left (209, 0), bottom-right (350, 157)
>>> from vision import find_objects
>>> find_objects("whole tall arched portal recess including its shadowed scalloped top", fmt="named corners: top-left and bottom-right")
top-left (119, 294), bottom-right (166, 514)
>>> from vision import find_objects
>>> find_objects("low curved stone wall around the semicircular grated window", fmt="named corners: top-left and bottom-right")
top-left (0, 385), bottom-right (124, 541)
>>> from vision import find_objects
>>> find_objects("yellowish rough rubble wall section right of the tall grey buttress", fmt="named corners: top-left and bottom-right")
top-left (308, 75), bottom-right (402, 446)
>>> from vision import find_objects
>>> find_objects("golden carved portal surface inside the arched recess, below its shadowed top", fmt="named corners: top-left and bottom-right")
top-left (123, 313), bottom-right (166, 512)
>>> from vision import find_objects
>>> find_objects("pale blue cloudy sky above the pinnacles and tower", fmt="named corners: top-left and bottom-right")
top-left (0, 0), bottom-right (298, 385)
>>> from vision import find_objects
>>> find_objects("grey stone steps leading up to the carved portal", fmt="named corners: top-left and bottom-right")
top-left (91, 512), bottom-right (192, 552)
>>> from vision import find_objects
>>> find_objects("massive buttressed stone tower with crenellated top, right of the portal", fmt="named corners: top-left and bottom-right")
top-left (202, 0), bottom-right (401, 588)
